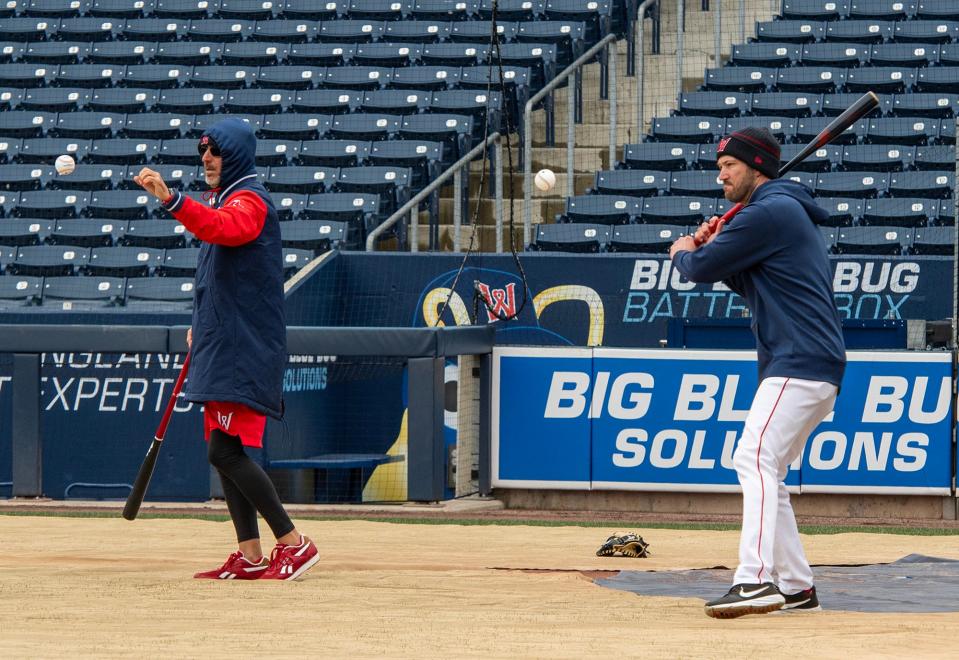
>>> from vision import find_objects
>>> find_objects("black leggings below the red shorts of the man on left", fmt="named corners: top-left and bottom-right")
top-left (207, 429), bottom-right (294, 543)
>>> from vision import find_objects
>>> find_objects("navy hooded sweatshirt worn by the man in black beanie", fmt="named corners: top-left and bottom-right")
top-left (673, 179), bottom-right (846, 387)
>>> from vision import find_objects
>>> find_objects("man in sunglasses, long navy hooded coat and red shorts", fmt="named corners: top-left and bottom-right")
top-left (134, 118), bottom-right (319, 580)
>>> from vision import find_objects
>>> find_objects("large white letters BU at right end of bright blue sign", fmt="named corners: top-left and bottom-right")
top-left (862, 376), bottom-right (952, 424)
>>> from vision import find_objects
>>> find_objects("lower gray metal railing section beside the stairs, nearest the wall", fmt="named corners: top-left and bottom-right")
top-left (366, 132), bottom-right (503, 252)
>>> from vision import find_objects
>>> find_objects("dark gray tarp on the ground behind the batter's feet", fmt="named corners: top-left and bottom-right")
top-left (596, 555), bottom-right (959, 612)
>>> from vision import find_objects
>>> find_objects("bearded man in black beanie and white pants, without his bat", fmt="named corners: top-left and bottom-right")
top-left (669, 128), bottom-right (846, 618)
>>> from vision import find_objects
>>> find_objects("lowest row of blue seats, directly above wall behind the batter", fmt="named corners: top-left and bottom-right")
top-left (530, 224), bottom-right (955, 256)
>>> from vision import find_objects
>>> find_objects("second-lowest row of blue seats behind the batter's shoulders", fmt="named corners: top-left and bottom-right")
top-left (556, 193), bottom-right (955, 227)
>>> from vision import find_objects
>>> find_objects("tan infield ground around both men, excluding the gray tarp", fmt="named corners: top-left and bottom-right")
top-left (0, 515), bottom-right (959, 658)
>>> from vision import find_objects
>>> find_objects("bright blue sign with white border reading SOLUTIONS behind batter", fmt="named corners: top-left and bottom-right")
top-left (491, 347), bottom-right (954, 495)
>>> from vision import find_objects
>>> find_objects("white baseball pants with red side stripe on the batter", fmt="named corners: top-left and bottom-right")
top-left (733, 377), bottom-right (838, 594)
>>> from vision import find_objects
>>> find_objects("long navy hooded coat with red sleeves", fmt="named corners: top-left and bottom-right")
top-left (158, 118), bottom-right (287, 418)
